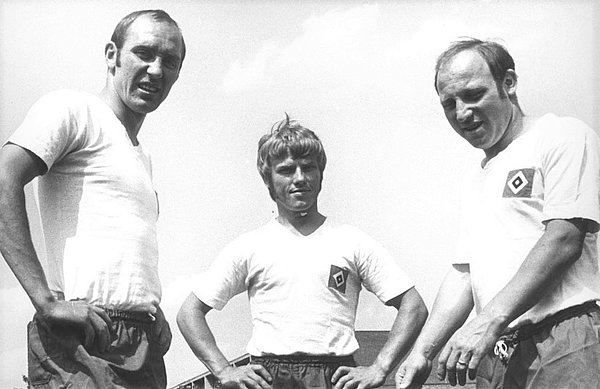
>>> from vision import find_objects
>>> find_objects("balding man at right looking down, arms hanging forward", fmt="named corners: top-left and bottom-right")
top-left (396, 39), bottom-right (600, 388)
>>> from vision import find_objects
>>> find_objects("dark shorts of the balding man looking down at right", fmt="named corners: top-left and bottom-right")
top-left (476, 304), bottom-right (600, 389)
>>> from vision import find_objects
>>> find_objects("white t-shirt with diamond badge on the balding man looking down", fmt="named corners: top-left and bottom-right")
top-left (454, 114), bottom-right (600, 327)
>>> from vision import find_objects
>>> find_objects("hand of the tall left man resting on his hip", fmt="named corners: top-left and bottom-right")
top-left (41, 300), bottom-right (113, 352)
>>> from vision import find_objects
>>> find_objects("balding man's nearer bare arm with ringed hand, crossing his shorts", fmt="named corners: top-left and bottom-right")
top-left (438, 219), bottom-right (587, 385)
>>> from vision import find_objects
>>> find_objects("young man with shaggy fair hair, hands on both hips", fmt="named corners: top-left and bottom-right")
top-left (177, 118), bottom-right (427, 389)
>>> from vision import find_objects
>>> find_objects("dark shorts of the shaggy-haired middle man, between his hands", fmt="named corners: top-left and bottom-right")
top-left (250, 355), bottom-right (356, 389)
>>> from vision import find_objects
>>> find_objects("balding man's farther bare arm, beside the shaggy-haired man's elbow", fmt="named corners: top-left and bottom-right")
top-left (396, 264), bottom-right (474, 388)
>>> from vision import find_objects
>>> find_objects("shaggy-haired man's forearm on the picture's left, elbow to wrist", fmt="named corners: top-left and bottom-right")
top-left (177, 294), bottom-right (229, 376)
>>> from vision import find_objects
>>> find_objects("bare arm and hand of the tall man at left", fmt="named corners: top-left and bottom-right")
top-left (0, 144), bottom-right (110, 350)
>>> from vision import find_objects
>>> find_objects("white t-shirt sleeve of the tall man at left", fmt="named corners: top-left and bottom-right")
top-left (6, 91), bottom-right (85, 169)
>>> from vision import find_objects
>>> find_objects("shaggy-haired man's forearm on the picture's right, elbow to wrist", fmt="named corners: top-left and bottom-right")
top-left (373, 288), bottom-right (427, 376)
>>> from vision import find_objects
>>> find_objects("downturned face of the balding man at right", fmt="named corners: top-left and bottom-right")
top-left (436, 50), bottom-right (516, 157)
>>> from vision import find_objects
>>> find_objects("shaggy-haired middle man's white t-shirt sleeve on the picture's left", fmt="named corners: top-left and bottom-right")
top-left (192, 237), bottom-right (248, 310)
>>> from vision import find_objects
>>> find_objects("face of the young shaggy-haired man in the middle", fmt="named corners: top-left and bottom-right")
top-left (269, 156), bottom-right (321, 214)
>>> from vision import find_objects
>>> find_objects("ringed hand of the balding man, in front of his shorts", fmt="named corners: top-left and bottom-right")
top-left (437, 314), bottom-right (502, 386)
